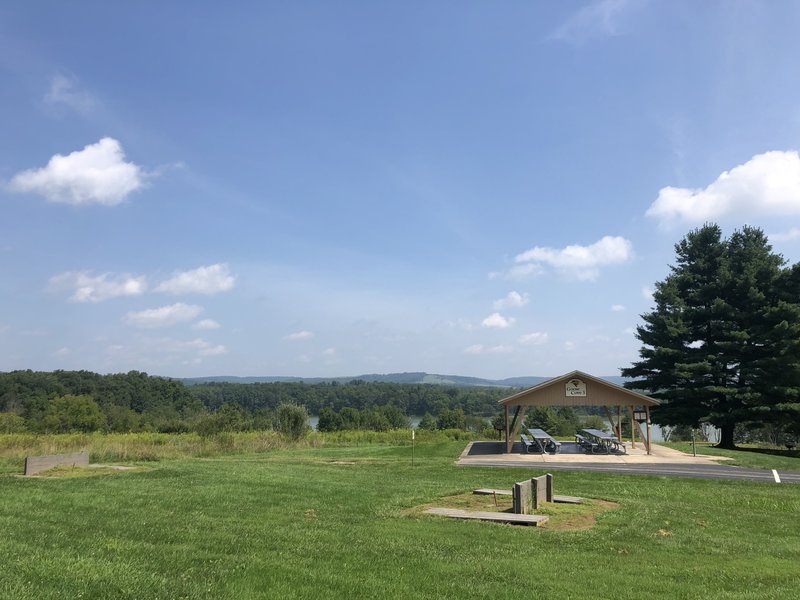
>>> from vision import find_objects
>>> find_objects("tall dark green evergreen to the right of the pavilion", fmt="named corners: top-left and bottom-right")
top-left (622, 225), bottom-right (800, 448)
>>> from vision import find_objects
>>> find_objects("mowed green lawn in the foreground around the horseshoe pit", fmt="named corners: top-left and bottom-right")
top-left (0, 440), bottom-right (800, 600)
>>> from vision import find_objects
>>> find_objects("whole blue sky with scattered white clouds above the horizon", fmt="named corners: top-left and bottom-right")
top-left (0, 0), bottom-right (800, 378)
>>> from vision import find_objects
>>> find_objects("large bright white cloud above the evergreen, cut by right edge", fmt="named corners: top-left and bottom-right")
top-left (646, 151), bottom-right (800, 225)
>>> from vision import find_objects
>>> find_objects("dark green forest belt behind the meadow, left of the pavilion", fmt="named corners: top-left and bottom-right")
top-left (0, 370), bottom-right (512, 433)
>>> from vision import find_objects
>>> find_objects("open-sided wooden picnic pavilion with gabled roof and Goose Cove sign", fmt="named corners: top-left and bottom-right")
top-left (499, 371), bottom-right (659, 454)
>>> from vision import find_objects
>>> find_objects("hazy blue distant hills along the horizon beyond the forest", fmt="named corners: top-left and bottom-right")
top-left (181, 372), bottom-right (625, 388)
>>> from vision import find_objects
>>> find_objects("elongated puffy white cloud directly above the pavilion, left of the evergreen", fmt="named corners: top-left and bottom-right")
top-left (512, 235), bottom-right (633, 281)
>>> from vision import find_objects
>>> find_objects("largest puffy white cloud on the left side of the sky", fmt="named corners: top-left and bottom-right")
top-left (8, 137), bottom-right (144, 206)
